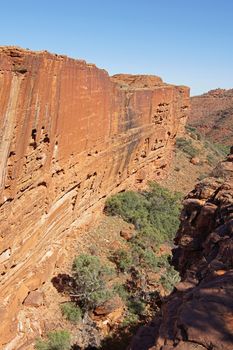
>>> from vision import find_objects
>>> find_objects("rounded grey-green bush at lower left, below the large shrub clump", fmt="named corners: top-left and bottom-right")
top-left (72, 254), bottom-right (113, 310)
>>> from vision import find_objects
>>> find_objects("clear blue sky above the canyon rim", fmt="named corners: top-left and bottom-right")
top-left (0, 0), bottom-right (233, 95)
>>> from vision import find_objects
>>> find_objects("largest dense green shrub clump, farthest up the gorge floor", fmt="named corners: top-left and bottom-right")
top-left (105, 183), bottom-right (181, 247)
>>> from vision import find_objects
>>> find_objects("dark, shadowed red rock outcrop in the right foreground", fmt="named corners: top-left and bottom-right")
top-left (131, 147), bottom-right (233, 350)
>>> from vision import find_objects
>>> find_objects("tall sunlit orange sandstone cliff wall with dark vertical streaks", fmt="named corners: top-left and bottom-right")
top-left (0, 47), bottom-right (189, 344)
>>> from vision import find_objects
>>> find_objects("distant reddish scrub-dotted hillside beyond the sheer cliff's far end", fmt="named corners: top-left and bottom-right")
top-left (189, 89), bottom-right (233, 146)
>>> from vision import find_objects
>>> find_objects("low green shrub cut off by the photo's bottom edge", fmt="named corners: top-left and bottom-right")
top-left (35, 330), bottom-right (71, 350)
